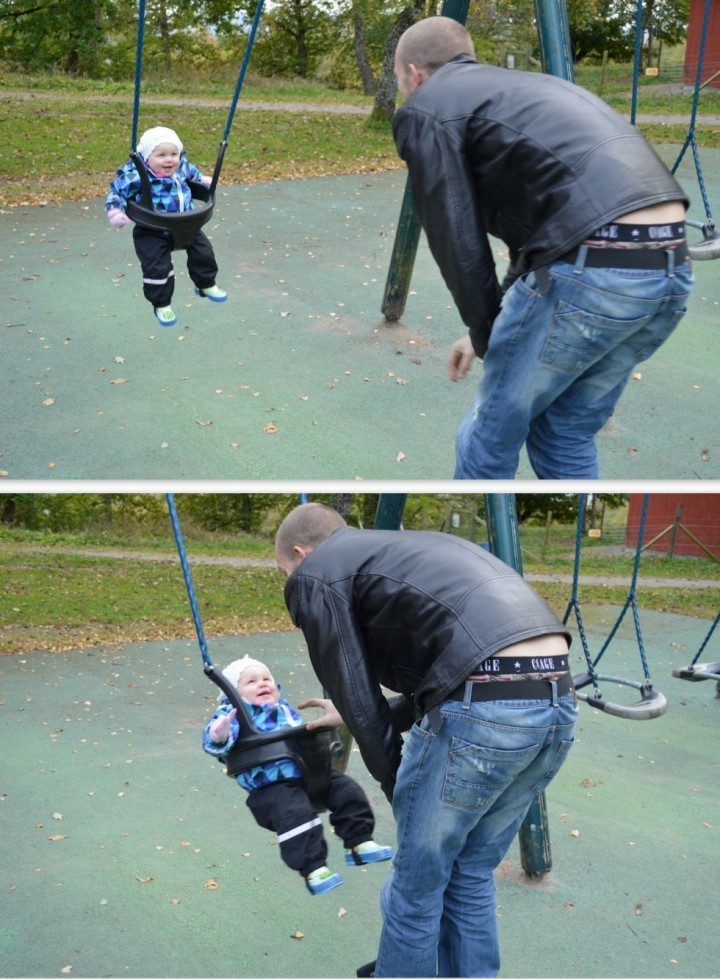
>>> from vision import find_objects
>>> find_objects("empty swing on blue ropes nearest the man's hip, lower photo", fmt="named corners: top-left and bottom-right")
top-left (563, 493), bottom-right (667, 720)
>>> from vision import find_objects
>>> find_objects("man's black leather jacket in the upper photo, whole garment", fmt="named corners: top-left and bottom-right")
top-left (393, 55), bottom-right (689, 357)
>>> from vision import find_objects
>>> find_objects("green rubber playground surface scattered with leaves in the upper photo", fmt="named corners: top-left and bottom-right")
top-left (0, 147), bottom-right (720, 481)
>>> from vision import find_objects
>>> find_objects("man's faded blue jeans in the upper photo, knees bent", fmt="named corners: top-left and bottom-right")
top-left (455, 255), bottom-right (693, 479)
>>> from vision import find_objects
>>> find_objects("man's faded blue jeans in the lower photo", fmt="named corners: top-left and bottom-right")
top-left (374, 694), bottom-right (577, 976)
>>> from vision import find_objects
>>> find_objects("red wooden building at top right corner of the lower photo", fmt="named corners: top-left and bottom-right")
top-left (625, 493), bottom-right (720, 558)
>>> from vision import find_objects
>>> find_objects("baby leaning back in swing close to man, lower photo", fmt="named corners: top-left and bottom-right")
top-left (202, 656), bottom-right (393, 894)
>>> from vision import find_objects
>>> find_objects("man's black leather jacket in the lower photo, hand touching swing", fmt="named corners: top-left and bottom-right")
top-left (285, 528), bottom-right (570, 799)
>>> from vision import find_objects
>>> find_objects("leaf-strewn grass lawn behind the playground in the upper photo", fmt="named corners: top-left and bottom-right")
top-left (0, 66), bottom-right (720, 208)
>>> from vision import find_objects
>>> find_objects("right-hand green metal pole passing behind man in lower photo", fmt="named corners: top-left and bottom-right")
top-left (485, 493), bottom-right (552, 877)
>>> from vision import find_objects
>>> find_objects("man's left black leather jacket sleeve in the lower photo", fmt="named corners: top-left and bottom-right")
top-left (286, 574), bottom-right (402, 801)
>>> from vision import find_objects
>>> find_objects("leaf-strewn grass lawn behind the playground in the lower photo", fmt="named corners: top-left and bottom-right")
top-left (0, 528), bottom-right (718, 655)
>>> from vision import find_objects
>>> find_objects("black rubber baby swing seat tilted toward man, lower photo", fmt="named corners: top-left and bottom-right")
top-left (205, 666), bottom-right (343, 812)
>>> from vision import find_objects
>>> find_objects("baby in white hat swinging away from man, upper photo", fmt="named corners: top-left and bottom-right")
top-left (105, 126), bottom-right (227, 326)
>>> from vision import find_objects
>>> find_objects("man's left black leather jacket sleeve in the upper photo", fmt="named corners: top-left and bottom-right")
top-left (393, 105), bottom-right (500, 357)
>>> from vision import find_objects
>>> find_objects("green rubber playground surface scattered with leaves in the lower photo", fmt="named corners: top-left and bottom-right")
top-left (0, 607), bottom-right (720, 977)
